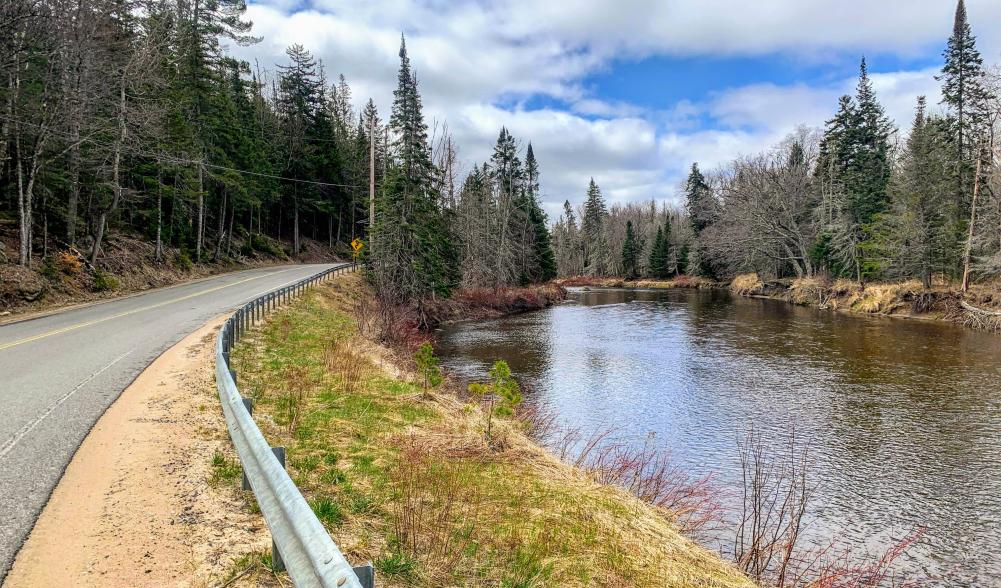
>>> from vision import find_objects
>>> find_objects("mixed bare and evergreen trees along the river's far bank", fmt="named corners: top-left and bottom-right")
top-left (555, 1), bottom-right (1001, 288)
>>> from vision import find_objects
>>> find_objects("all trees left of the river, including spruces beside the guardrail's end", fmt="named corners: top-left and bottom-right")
top-left (0, 0), bottom-right (556, 308)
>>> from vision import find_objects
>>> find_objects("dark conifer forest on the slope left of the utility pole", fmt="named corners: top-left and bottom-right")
top-left (0, 0), bottom-right (376, 265)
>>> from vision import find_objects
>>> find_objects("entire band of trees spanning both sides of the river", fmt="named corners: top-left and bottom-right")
top-left (0, 0), bottom-right (1001, 308)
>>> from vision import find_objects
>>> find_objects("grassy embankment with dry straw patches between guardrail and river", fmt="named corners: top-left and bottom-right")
top-left (221, 275), bottom-right (752, 587)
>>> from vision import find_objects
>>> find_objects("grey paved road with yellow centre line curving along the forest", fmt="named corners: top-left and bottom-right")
top-left (0, 265), bottom-right (340, 582)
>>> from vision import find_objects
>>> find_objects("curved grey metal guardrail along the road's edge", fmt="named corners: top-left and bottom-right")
top-left (215, 263), bottom-right (373, 588)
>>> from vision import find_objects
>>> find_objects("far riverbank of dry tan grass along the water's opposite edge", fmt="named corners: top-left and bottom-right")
top-left (559, 273), bottom-right (1001, 332)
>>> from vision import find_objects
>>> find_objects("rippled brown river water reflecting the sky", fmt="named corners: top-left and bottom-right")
top-left (438, 289), bottom-right (1001, 586)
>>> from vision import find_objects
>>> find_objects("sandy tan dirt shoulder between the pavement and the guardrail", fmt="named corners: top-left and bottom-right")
top-left (4, 318), bottom-right (270, 588)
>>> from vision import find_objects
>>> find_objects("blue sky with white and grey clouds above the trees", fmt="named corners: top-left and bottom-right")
top-left (229, 0), bottom-right (1001, 218)
